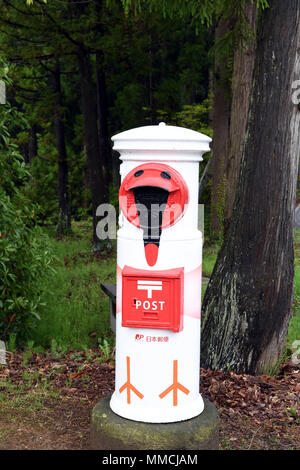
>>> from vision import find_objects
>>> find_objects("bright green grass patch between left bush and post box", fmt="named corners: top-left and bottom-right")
top-left (32, 221), bottom-right (116, 352)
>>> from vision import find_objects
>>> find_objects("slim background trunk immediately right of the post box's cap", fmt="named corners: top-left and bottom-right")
top-left (210, 20), bottom-right (230, 238)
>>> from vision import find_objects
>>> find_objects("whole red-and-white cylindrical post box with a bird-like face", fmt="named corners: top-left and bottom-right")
top-left (110, 123), bottom-right (211, 423)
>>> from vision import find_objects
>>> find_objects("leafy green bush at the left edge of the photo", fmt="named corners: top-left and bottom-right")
top-left (0, 105), bottom-right (53, 344)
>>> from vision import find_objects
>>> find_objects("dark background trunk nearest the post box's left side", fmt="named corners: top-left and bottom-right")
top-left (78, 50), bottom-right (107, 251)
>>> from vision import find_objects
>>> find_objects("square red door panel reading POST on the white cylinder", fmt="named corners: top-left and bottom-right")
top-left (122, 266), bottom-right (184, 332)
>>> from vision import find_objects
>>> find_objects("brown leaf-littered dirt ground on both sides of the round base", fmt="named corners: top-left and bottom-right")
top-left (0, 350), bottom-right (300, 450)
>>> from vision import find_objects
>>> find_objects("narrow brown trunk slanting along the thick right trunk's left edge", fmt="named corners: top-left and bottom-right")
top-left (225, 0), bottom-right (257, 227)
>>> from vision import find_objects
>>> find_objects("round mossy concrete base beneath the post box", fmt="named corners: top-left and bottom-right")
top-left (90, 395), bottom-right (219, 450)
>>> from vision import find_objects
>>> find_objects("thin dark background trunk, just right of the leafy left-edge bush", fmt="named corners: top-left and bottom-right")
top-left (53, 60), bottom-right (71, 234)
